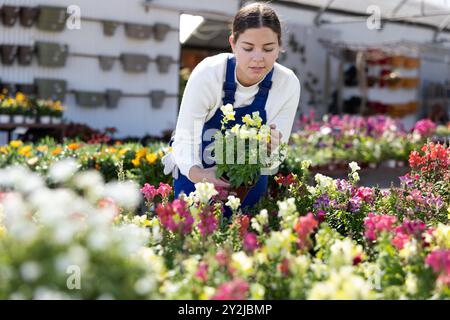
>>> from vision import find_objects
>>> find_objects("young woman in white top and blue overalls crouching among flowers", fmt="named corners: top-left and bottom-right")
top-left (163, 3), bottom-right (300, 212)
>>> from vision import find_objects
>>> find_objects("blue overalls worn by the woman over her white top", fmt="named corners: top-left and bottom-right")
top-left (174, 56), bottom-right (273, 217)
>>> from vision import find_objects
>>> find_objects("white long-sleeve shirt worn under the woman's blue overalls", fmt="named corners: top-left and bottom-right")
top-left (164, 53), bottom-right (300, 178)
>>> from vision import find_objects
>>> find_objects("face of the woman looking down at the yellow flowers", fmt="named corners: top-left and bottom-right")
top-left (229, 27), bottom-right (280, 86)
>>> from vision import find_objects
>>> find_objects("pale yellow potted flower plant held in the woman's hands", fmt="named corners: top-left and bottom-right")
top-left (214, 104), bottom-right (286, 203)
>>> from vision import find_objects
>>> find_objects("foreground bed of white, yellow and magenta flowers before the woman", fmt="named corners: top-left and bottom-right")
top-left (0, 143), bottom-right (450, 299)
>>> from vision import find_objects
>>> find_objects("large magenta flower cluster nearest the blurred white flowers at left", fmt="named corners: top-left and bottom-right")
top-left (156, 199), bottom-right (194, 234)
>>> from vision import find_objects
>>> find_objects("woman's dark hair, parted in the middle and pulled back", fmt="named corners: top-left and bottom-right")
top-left (231, 2), bottom-right (281, 46)
